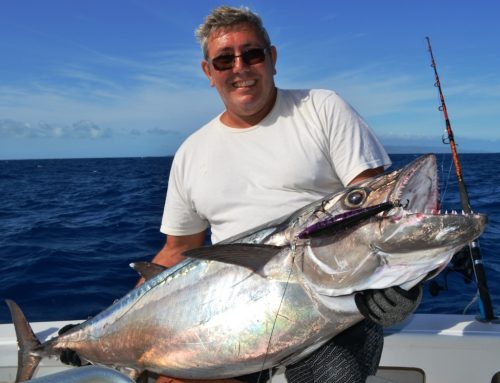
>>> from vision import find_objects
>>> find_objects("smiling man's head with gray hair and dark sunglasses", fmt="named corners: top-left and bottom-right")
top-left (196, 7), bottom-right (277, 127)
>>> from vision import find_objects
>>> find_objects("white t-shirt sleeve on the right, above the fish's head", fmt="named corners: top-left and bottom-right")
top-left (323, 93), bottom-right (391, 186)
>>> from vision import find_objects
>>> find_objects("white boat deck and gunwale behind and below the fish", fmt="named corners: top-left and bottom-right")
top-left (0, 314), bottom-right (500, 383)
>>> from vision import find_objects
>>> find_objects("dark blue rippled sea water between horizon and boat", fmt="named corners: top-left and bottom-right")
top-left (0, 154), bottom-right (500, 323)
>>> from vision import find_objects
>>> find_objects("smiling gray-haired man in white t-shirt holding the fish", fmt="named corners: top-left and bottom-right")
top-left (149, 7), bottom-right (421, 382)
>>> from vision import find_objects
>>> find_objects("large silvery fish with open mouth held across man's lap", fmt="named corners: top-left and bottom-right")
top-left (8, 155), bottom-right (486, 382)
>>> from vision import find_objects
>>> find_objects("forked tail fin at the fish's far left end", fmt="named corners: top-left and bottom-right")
top-left (5, 299), bottom-right (42, 383)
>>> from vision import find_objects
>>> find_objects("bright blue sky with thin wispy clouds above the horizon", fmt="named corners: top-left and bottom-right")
top-left (0, 0), bottom-right (500, 159)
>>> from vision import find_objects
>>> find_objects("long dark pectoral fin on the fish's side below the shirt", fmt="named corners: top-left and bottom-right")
top-left (182, 243), bottom-right (282, 272)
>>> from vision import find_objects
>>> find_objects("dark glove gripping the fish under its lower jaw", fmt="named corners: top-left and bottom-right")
top-left (354, 284), bottom-right (422, 327)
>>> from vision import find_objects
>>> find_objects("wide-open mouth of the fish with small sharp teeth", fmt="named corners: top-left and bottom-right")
top-left (373, 154), bottom-right (487, 253)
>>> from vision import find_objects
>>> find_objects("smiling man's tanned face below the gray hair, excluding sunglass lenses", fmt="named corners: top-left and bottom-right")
top-left (202, 24), bottom-right (276, 127)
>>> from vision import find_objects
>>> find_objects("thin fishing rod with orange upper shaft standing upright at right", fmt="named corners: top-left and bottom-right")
top-left (426, 37), bottom-right (495, 322)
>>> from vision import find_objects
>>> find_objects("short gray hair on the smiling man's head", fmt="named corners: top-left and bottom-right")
top-left (195, 6), bottom-right (271, 59)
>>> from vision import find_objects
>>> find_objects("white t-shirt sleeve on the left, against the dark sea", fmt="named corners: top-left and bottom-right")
top-left (160, 152), bottom-right (209, 235)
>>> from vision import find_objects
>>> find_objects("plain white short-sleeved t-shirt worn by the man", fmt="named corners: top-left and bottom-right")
top-left (160, 89), bottom-right (391, 243)
